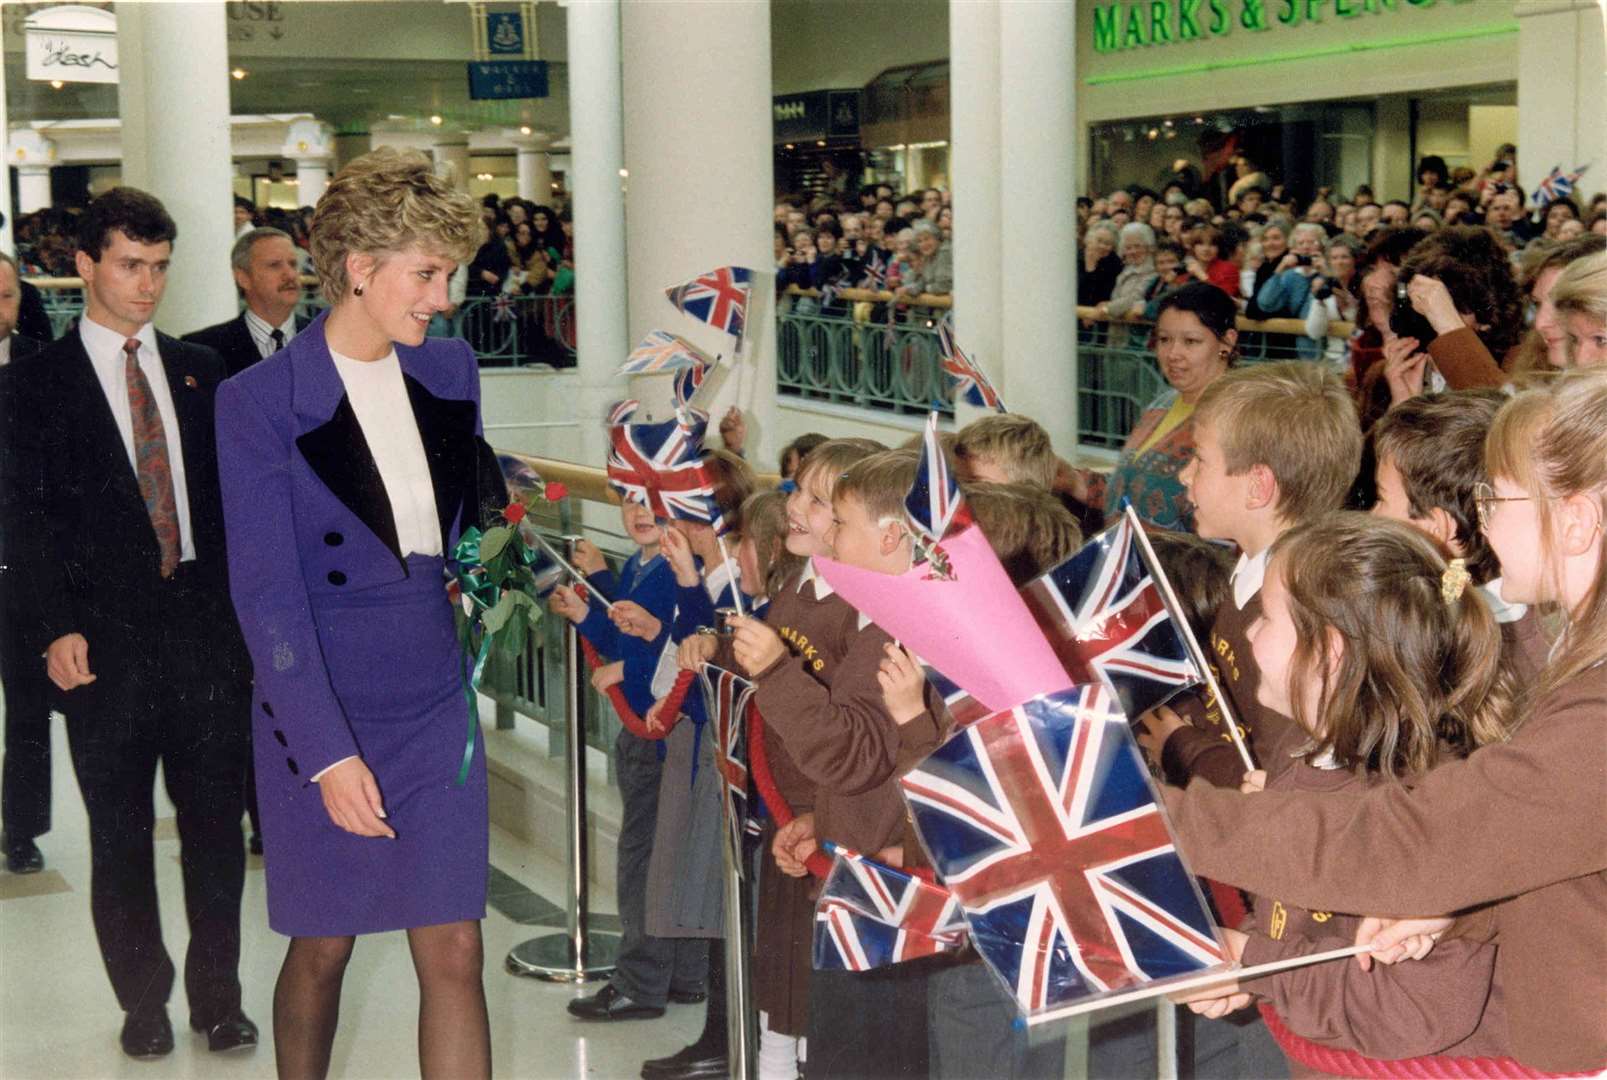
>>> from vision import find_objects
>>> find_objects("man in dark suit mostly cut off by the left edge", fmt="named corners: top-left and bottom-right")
top-left (0, 252), bottom-right (50, 874)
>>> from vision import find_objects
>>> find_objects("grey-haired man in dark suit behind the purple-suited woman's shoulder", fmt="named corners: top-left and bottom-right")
top-left (185, 228), bottom-right (309, 374)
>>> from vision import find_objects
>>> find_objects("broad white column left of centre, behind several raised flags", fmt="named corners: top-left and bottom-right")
top-left (617, 0), bottom-right (776, 464)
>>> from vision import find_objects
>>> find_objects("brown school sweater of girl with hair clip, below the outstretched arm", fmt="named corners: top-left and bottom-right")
top-left (1241, 762), bottom-right (1507, 1061)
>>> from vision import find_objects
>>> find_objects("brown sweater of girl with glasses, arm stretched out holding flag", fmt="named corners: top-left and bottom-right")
top-left (1167, 664), bottom-right (1607, 1072)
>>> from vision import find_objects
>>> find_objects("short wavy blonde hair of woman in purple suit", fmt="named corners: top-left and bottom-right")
top-left (309, 146), bottom-right (485, 304)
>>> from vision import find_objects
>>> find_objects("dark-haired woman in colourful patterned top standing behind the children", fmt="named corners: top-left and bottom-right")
top-left (1061, 281), bottom-right (1239, 532)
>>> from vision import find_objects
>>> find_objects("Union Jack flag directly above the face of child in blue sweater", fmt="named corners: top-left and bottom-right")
top-left (607, 402), bottom-right (725, 529)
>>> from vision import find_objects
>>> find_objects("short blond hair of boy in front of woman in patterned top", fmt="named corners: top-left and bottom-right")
top-left (1194, 360), bottom-right (1361, 524)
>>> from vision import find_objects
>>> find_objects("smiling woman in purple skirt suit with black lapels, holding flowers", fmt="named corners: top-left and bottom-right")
top-left (217, 149), bottom-right (506, 1078)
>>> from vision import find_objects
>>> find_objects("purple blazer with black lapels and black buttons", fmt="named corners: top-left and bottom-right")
top-left (217, 308), bottom-right (506, 788)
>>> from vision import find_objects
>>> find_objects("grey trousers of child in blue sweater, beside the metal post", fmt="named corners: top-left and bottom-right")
top-left (611, 730), bottom-right (709, 1006)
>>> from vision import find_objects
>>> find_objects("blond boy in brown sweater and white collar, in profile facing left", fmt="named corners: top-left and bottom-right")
top-left (1139, 362), bottom-right (1361, 788)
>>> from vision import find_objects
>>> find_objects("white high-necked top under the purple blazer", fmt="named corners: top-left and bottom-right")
top-left (329, 349), bottom-right (442, 556)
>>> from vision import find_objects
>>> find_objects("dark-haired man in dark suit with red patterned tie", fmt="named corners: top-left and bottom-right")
top-left (6, 188), bottom-right (257, 1058)
